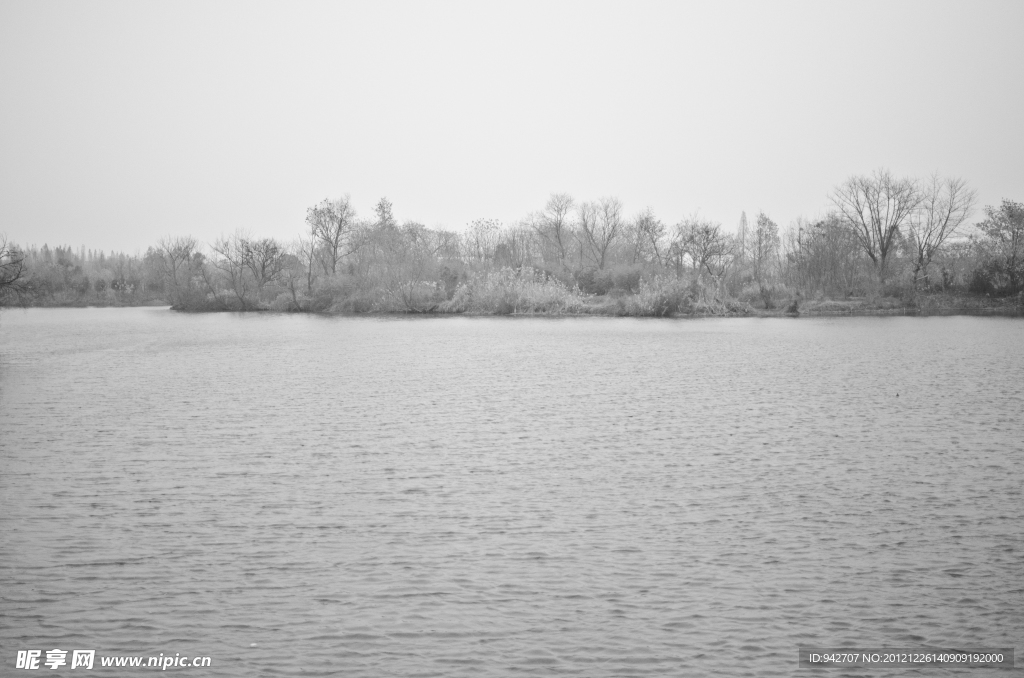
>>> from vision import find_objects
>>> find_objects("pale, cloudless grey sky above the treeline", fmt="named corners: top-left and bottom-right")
top-left (0, 0), bottom-right (1024, 252)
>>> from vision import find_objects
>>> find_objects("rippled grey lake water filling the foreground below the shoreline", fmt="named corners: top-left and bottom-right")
top-left (0, 308), bottom-right (1024, 677)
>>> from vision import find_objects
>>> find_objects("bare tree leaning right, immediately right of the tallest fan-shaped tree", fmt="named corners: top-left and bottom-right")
top-left (906, 174), bottom-right (977, 284)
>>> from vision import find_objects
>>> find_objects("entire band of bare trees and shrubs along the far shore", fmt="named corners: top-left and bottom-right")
top-left (6, 170), bottom-right (1024, 316)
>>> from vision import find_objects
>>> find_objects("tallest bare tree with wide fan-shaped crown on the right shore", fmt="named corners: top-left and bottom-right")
top-left (830, 170), bottom-right (922, 283)
